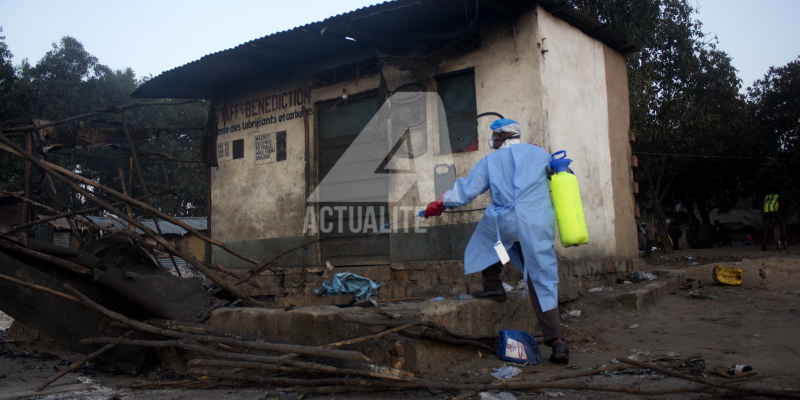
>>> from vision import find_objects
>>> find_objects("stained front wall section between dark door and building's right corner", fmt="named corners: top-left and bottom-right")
top-left (387, 9), bottom-right (546, 262)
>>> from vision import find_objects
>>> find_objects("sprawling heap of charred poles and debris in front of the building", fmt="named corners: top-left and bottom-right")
top-left (0, 102), bottom-right (800, 399)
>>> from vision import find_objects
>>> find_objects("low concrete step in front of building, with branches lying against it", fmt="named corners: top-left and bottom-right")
top-left (206, 292), bottom-right (537, 373)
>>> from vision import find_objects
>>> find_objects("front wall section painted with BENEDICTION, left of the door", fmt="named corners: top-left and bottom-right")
top-left (211, 81), bottom-right (312, 241)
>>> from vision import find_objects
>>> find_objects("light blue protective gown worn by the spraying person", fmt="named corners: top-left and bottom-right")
top-left (443, 143), bottom-right (558, 311)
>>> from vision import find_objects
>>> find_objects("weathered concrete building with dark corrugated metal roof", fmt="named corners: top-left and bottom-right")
top-left (134, 0), bottom-right (638, 300)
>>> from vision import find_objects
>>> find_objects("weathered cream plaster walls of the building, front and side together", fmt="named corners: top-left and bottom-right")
top-left (212, 4), bottom-right (636, 276)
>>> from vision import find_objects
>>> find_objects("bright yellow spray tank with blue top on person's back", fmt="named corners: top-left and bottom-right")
top-left (550, 150), bottom-right (589, 247)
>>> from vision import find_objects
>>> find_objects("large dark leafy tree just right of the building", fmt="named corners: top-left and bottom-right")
top-left (573, 0), bottom-right (747, 253)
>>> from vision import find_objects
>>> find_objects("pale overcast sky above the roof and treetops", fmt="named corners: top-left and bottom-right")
top-left (0, 0), bottom-right (800, 91)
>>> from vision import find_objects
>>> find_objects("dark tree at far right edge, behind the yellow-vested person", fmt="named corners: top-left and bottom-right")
top-left (747, 57), bottom-right (800, 212)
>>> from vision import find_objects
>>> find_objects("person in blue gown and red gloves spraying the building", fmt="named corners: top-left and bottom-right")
top-left (425, 119), bottom-right (569, 364)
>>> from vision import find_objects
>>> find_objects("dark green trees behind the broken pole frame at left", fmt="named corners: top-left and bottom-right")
top-left (0, 36), bottom-right (208, 216)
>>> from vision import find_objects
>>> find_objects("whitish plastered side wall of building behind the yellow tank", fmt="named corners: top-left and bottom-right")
top-left (538, 7), bottom-right (620, 260)
